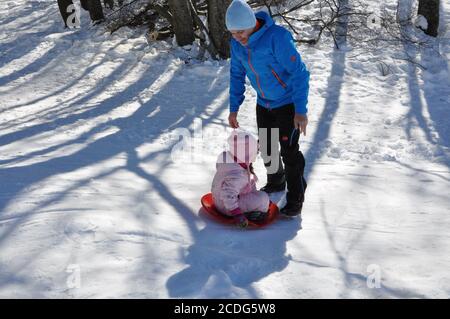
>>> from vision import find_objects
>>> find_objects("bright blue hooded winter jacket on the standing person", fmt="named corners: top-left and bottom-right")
top-left (230, 12), bottom-right (309, 114)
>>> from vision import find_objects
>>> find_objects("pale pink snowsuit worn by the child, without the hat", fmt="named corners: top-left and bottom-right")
top-left (211, 152), bottom-right (270, 215)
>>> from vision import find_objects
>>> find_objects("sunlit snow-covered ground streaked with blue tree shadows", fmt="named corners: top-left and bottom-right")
top-left (0, 0), bottom-right (450, 298)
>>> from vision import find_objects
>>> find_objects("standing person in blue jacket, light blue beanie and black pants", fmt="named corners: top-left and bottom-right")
top-left (226, 0), bottom-right (309, 216)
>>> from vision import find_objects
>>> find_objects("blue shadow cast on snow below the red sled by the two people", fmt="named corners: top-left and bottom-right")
top-left (166, 209), bottom-right (301, 298)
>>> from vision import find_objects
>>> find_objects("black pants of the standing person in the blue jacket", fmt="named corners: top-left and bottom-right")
top-left (256, 104), bottom-right (307, 202)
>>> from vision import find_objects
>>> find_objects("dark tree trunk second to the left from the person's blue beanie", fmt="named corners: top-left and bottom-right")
top-left (169, 0), bottom-right (195, 46)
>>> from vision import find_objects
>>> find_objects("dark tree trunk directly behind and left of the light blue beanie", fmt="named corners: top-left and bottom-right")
top-left (208, 0), bottom-right (232, 59)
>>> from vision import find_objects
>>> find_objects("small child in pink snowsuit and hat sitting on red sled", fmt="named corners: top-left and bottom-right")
top-left (211, 131), bottom-right (270, 227)
